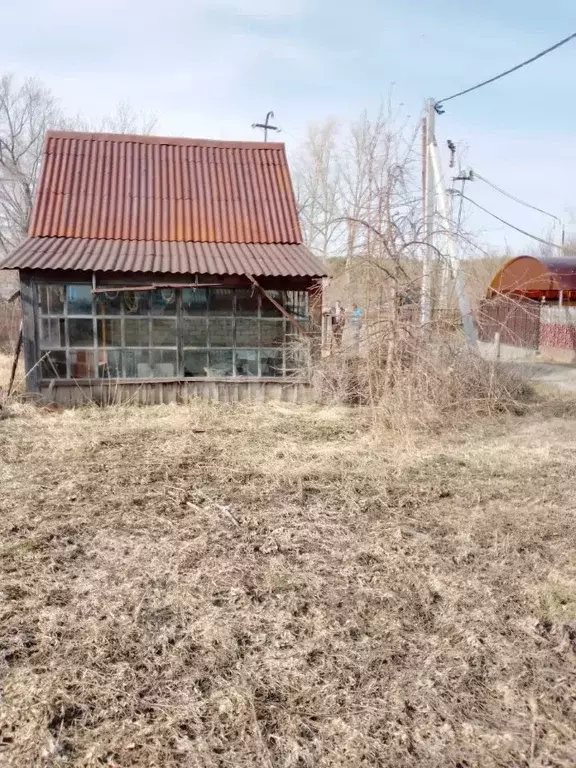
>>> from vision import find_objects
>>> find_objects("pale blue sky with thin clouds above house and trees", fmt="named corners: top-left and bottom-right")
top-left (0, 0), bottom-right (576, 252)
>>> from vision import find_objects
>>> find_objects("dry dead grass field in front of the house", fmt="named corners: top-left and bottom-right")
top-left (0, 382), bottom-right (576, 768)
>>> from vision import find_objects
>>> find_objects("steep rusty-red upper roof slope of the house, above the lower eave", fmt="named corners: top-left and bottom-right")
top-left (29, 131), bottom-right (302, 243)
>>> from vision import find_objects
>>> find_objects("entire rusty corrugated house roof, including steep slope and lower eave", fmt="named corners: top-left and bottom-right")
top-left (2, 131), bottom-right (325, 276)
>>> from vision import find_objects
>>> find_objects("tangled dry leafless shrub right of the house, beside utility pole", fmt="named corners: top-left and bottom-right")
top-left (312, 329), bottom-right (532, 429)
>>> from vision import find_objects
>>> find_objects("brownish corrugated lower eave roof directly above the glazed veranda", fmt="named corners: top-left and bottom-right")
top-left (2, 237), bottom-right (326, 277)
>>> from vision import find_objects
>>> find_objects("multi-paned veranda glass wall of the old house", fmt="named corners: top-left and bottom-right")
top-left (37, 283), bottom-right (309, 379)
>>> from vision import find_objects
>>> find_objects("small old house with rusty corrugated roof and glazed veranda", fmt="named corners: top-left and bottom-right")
top-left (2, 132), bottom-right (325, 404)
